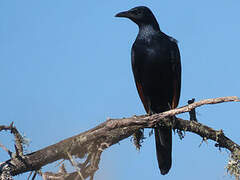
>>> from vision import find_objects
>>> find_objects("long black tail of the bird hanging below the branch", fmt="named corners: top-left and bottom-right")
top-left (154, 128), bottom-right (172, 175)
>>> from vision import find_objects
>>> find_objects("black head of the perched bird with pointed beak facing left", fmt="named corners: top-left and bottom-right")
top-left (115, 6), bottom-right (158, 26)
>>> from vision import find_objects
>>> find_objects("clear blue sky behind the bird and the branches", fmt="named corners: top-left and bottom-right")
top-left (0, 0), bottom-right (240, 180)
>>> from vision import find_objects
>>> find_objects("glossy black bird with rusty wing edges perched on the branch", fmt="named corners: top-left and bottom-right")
top-left (116, 6), bottom-right (181, 175)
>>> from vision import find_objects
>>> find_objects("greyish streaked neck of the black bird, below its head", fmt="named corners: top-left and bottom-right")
top-left (137, 24), bottom-right (160, 39)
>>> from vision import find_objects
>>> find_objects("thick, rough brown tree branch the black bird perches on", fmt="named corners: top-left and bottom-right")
top-left (0, 96), bottom-right (240, 178)
